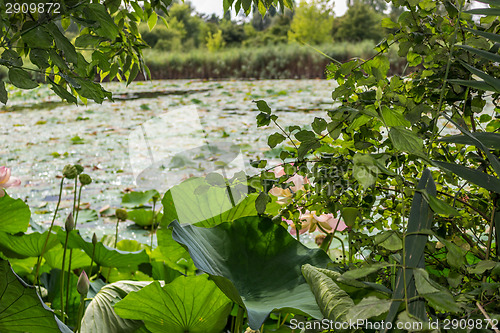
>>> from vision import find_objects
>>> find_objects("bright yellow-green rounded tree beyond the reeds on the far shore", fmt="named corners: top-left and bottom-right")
top-left (288, 0), bottom-right (333, 44)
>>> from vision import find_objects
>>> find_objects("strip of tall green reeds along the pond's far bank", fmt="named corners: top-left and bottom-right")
top-left (0, 40), bottom-right (406, 82)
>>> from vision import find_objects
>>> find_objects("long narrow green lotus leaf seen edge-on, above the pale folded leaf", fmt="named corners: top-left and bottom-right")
top-left (57, 230), bottom-right (149, 269)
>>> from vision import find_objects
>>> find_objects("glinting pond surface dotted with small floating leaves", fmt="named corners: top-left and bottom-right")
top-left (0, 80), bottom-right (334, 242)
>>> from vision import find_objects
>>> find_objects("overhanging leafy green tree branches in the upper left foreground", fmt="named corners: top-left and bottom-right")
top-left (0, 0), bottom-right (291, 104)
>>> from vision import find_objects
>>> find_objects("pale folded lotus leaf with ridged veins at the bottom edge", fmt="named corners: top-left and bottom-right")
top-left (81, 281), bottom-right (151, 333)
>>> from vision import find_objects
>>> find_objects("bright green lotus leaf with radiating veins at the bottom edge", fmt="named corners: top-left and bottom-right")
top-left (115, 274), bottom-right (232, 333)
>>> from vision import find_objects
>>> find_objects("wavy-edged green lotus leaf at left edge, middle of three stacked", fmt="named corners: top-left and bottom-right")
top-left (0, 231), bottom-right (59, 258)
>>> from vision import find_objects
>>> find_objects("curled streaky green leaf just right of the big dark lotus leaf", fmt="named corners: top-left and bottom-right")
top-left (302, 264), bottom-right (354, 322)
